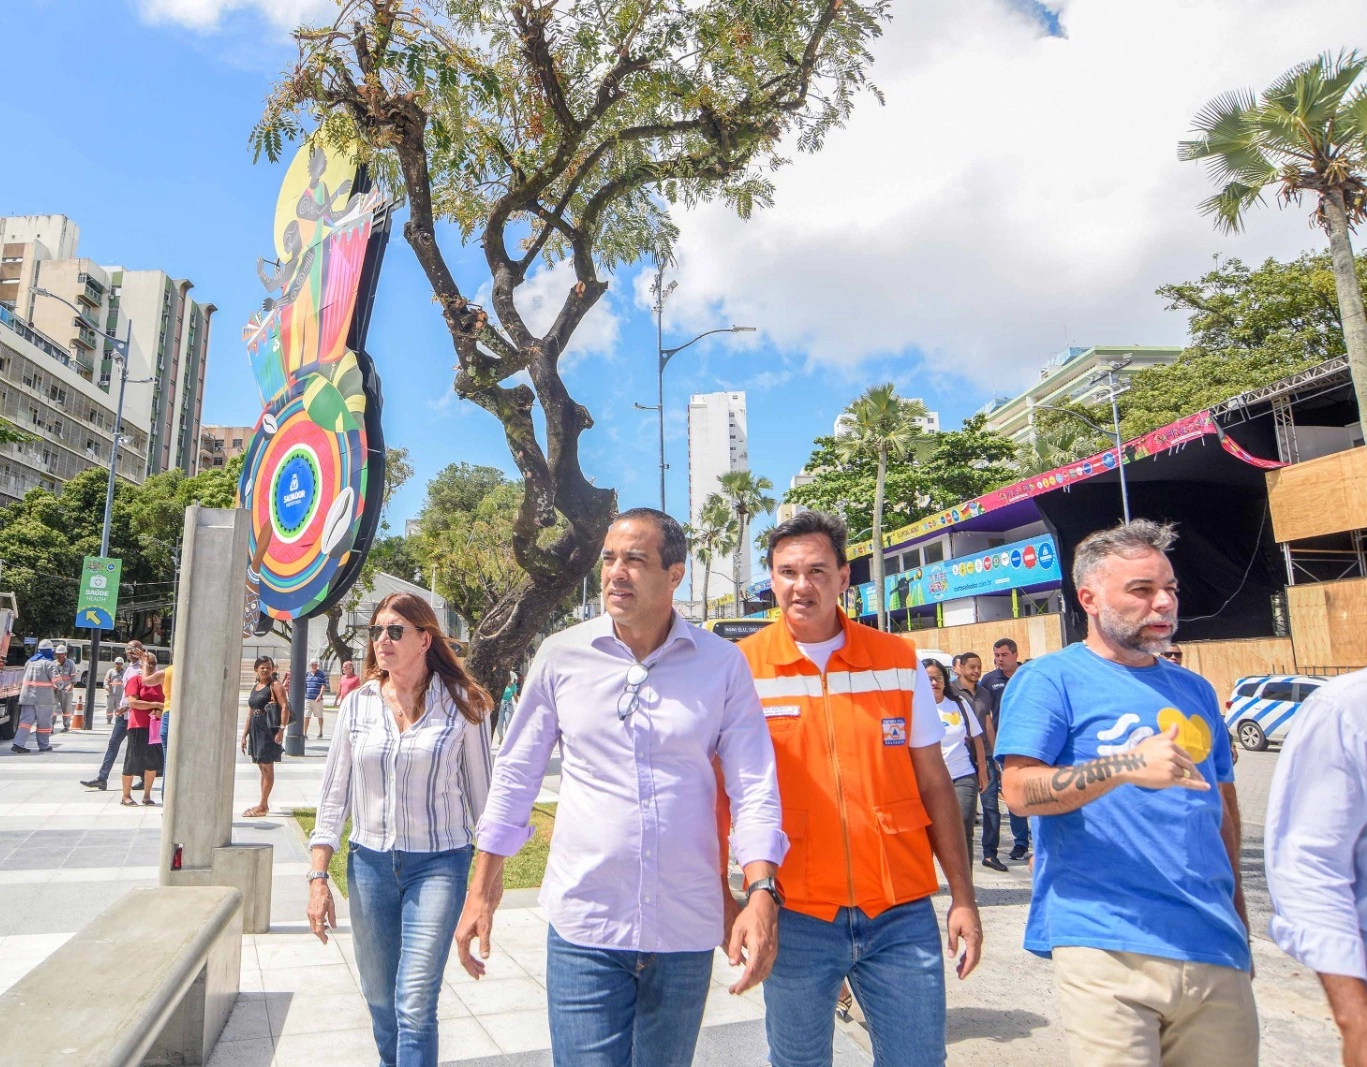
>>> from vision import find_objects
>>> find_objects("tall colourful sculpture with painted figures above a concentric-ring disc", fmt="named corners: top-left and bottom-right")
top-left (238, 137), bottom-right (388, 633)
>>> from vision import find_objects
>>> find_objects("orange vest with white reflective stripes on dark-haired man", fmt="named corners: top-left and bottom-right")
top-left (740, 612), bottom-right (939, 922)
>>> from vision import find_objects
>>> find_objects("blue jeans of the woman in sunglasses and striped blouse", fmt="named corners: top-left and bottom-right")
top-left (346, 844), bottom-right (473, 1067)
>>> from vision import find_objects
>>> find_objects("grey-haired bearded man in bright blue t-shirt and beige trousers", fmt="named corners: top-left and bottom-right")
top-left (997, 519), bottom-right (1258, 1067)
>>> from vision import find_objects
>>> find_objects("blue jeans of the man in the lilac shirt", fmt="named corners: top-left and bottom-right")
top-left (545, 926), bottom-right (712, 1067)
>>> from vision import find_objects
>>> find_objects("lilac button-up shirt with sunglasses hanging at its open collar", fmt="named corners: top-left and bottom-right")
top-left (476, 613), bottom-right (787, 952)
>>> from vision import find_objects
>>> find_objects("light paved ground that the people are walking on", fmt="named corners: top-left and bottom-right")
top-left (0, 715), bottom-right (1338, 1067)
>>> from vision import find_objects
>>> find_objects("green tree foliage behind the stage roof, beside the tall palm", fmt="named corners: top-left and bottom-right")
top-left (1120, 253), bottom-right (1367, 437)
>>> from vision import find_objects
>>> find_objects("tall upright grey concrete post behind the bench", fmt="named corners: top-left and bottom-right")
top-left (161, 505), bottom-right (271, 933)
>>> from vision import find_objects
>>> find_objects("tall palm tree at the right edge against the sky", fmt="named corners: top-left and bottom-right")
top-left (1177, 52), bottom-right (1367, 413)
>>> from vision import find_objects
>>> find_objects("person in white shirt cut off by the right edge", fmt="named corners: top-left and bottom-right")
top-left (1263, 661), bottom-right (1367, 1067)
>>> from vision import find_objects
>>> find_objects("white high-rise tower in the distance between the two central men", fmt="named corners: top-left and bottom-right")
top-left (688, 392), bottom-right (750, 601)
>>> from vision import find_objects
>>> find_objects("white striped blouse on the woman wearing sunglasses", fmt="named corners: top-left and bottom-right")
top-left (309, 675), bottom-right (493, 853)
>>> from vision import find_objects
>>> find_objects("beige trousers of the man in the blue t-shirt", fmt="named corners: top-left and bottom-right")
top-left (1054, 947), bottom-right (1258, 1067)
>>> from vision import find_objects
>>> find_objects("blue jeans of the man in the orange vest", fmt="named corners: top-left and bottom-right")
top-left (764, 898), bottom-right (945, 1067)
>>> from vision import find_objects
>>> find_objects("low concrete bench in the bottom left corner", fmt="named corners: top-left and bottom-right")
top-left (0, 885), bottom-right (242, 1067)
